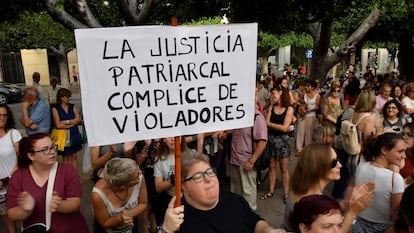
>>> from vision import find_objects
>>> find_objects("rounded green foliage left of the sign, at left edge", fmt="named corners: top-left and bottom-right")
top-left (0, 12), bottom-right (74, 51)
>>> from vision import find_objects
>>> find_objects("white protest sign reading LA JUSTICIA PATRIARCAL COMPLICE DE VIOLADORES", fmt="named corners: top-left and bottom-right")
top-left (75, 23), bottom-right (257, 145)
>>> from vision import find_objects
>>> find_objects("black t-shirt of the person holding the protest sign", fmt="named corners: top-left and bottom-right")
top-left (179, 192), bottom-right (263, 233)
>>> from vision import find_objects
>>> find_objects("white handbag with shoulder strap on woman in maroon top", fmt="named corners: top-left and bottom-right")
top-left (22, 162), bottom-right (58, 233)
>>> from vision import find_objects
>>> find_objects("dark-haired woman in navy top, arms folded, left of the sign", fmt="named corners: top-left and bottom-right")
top-left (52, 88), bottom-right (82, 170)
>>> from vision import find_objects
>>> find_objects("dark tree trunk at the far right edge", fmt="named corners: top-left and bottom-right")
top-left (398, 34), bottom-right (414, 82)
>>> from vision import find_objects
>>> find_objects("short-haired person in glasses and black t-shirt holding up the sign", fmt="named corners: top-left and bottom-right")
top-left (157, 150), bottom-right (285, 233)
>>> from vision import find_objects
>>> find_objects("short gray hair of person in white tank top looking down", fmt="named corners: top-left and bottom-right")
top-left (104, 158), bottom-right (138, 186)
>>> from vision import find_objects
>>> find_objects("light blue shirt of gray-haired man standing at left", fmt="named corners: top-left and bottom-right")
top-left (26, 99), bottom-right (51, 135)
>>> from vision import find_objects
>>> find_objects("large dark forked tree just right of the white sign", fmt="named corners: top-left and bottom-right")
top-left (228, 0), bottom-right (381, 82)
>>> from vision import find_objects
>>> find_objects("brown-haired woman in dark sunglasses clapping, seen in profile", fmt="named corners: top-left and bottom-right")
top-left (282, 143), bottom-right (372, 232)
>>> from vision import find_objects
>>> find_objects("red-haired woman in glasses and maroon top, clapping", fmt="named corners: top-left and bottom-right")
top-left (7, 133), bottom-right (88, 233)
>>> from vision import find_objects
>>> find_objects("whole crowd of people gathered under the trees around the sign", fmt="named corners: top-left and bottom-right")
top-left (0, 66), bottom-right (414, 233)
